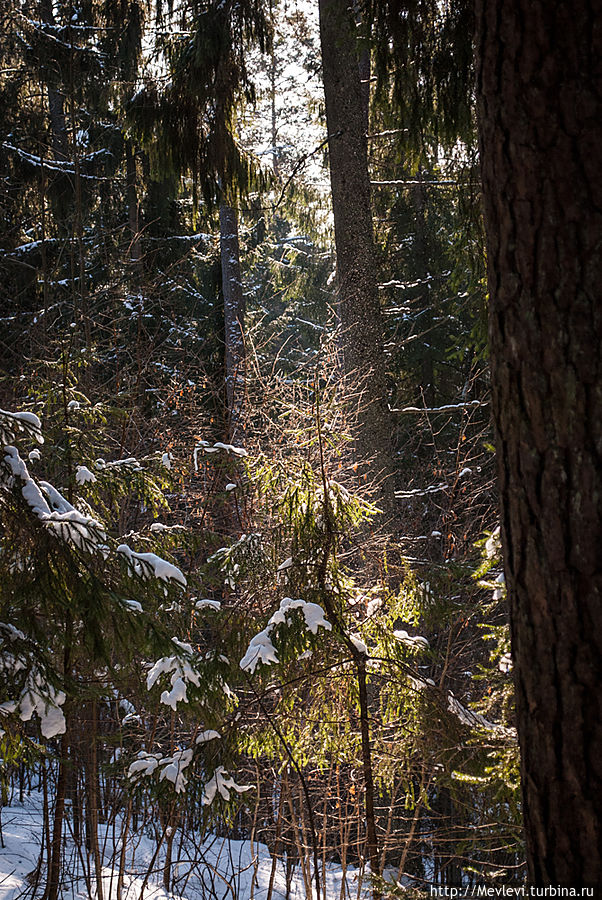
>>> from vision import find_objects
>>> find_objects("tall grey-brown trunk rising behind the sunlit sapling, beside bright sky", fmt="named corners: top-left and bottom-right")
top-left (319, 0), bottom-right (393, 514)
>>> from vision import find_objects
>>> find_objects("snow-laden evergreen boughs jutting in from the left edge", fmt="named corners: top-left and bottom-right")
top-left (0, 414), bottom-right (195, 752)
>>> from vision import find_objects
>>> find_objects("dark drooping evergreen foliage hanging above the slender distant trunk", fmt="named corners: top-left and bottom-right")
top-left (127, 0), bottom-right (270, 207)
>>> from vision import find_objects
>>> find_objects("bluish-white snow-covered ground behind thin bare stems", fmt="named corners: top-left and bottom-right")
top-left (0, 793), bottom-right (368, 900)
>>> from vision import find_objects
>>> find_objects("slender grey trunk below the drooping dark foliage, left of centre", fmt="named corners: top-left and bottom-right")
top-left (219, 204), bottom-right (246, 441)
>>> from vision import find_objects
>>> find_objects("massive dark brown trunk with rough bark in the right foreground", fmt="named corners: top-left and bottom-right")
top-left (477, 0), bottom-right (602, 886)
